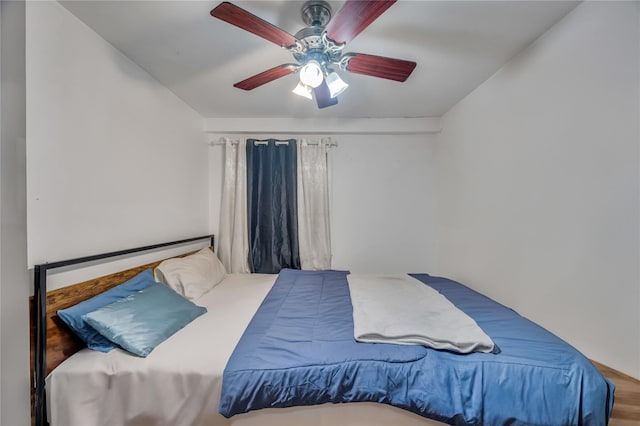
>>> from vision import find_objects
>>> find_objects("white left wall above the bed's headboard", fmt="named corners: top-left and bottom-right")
top-left (26, 2), bottom-right (209, 276)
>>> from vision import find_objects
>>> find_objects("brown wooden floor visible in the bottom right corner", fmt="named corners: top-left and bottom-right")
top-left (593, 362), bottom-right (640, 426)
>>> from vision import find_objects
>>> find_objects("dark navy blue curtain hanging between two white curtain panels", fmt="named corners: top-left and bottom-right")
top-left (247, 139), bottom-right (300, 274)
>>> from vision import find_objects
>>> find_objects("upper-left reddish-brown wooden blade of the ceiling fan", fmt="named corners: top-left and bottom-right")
top-left (211, 1), bottom-right (297, 48)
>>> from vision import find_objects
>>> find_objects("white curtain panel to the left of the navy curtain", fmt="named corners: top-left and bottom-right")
top-left (218, 139), bottom-right (250, 273)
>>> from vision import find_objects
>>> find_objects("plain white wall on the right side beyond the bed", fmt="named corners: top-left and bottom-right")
top-left (436, 2), bottom-right (640, 378)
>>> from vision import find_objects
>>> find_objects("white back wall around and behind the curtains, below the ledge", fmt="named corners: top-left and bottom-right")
top-left (209, 131), bottom-right (437, 272)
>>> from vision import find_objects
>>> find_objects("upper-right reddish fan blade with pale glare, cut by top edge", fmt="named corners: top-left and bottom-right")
top-left (326, 0), bottom-right (397, 44)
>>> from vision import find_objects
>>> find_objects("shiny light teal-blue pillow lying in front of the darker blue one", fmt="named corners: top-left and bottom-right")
top-left (82, 283), bottom-right (207, 357)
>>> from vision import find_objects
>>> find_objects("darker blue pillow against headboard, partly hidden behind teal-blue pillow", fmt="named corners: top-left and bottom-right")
top-left (58, 269), bottom-right (155, 352)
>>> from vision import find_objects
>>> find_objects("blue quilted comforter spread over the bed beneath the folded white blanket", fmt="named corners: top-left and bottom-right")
top-left (219, 270), bottom-right (614, 425)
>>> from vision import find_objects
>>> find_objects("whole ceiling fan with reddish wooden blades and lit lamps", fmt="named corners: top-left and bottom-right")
top-left (211, 0), bottom-right (416, 108)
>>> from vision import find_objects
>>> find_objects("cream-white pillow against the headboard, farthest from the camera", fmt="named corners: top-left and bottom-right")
top-left (154, 248), bottom-right (227, 300)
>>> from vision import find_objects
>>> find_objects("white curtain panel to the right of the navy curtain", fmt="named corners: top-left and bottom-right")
top-left (297, 139), bottom-right (331, 270)
